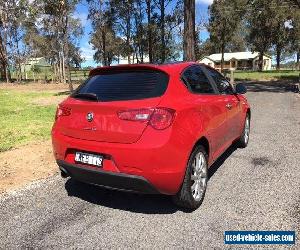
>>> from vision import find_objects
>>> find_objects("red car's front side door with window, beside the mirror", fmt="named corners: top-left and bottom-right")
top-left (206, 67), bottom-right (241, 143)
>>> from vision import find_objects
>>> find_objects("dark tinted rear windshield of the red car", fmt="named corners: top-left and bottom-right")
top-left (72, 70), bottom-right (169, 102)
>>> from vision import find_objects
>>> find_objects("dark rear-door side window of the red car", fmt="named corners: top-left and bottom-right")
top-left (183, 66), bottom-right (215, 94)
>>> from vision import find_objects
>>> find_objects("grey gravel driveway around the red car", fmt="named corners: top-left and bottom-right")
top-left (0, 81), bottom-right (300, 249)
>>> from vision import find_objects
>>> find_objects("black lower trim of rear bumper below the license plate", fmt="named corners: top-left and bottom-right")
top-left (57, 160), bottom-right (159, 194)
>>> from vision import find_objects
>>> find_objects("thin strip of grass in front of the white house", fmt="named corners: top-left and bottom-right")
top-left (234, 70), bottom-right (300, 81)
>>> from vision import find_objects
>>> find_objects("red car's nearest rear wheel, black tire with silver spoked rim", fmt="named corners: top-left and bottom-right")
top-left (173, 145), bottom-right (208, 210)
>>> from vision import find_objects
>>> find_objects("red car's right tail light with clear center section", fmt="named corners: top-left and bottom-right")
top-left (118, 108), bottom-right (175, 130)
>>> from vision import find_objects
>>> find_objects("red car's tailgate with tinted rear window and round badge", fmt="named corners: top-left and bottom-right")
top-left (57, 68), bottom-right (169, 143)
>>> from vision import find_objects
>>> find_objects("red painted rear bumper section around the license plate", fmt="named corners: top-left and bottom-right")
top-left (52, 128), bottom-right (195, 195)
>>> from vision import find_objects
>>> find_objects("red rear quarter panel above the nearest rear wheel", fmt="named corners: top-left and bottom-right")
top-left (159, 74), bottom-right (219, 165)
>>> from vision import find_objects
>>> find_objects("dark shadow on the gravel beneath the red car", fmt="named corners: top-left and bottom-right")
top-left (65, 146), bottom-right (236, 214)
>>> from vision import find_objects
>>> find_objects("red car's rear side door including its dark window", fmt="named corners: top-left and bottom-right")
top-left (183, 65), bottom-right (228, 158)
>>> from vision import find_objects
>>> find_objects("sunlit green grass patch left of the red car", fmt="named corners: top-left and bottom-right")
top-left (0, 90), bottom-right (56, 152)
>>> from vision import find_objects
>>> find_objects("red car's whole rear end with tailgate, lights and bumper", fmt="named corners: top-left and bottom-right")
top-left (52, 65), bottom-right (191, 194)
